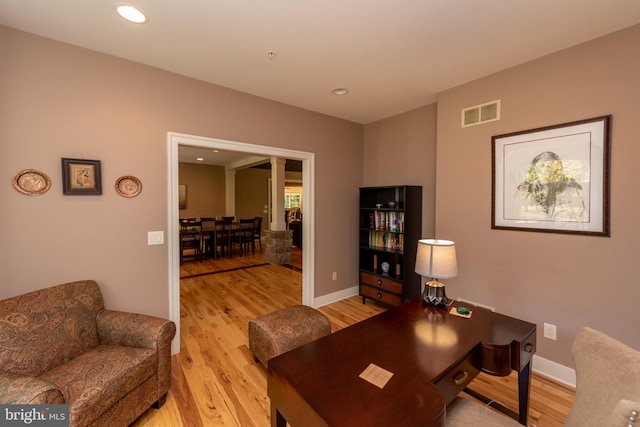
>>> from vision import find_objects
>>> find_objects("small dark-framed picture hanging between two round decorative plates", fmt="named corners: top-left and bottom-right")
top-left (62, 158), bottom-right (102, 195)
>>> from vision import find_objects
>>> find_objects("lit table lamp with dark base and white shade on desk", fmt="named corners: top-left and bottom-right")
top-left (415, 239), bottom-right (458, 307)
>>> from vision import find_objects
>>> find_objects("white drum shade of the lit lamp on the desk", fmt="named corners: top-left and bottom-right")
top-left (415, 239), bottom-right (458, 279)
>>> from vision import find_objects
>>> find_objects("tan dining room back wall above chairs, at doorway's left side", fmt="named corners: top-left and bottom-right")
top-left (178, 163), bottom-right (226, 218)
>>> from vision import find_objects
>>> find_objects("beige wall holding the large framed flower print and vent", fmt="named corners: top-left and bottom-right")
top-left (436, 26), bottom-right (640, 366)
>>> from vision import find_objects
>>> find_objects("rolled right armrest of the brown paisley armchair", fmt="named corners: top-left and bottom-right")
top-left (96, 309), bottom-right (176, 394)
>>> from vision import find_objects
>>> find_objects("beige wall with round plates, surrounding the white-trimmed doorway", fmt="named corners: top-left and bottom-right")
top-left (0, 27), bottom-right (363, 317)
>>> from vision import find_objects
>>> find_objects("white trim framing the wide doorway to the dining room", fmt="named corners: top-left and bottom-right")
top-left (167, 132), bottom-right (315, 354)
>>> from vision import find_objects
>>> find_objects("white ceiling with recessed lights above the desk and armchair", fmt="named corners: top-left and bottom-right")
top-left (0, 0), bottom-right (640, 124)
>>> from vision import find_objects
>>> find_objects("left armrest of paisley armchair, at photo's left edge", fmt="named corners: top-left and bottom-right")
top-left (0, 371), bottom-right (65, 405)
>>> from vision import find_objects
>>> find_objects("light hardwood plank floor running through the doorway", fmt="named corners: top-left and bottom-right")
top-left (133, 251), bottom-right (573, 427)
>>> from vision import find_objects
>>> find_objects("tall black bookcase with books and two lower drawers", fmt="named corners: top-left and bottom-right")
top-left (359, 185), bottom-right (422, 306)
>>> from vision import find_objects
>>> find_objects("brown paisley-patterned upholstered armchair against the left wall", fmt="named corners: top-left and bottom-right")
top-left (0, 280), bottom-right (176, 426)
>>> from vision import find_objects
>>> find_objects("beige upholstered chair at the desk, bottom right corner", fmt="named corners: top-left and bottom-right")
top-left (447, 327), bottom-right (640, 427)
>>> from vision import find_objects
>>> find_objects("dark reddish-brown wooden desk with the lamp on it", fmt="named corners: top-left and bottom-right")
top-left (267, 299), bottom-right (536, 427)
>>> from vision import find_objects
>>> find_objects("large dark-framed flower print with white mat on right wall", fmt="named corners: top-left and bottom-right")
top-left (491, 115), bottom-right (611, 237)
